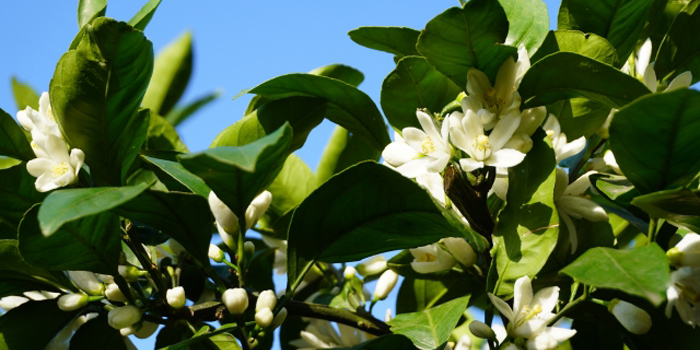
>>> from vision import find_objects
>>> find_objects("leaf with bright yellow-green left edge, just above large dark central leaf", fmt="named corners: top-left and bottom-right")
top-left (316, 126), bottom-right (381, 185)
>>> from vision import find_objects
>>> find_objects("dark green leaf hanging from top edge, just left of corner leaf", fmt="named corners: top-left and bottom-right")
top-left (559, 0), bottom-right (654, 59)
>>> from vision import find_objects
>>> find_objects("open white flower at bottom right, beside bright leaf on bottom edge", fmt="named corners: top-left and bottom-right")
top-left (489, 276), bottom-right (576, 342)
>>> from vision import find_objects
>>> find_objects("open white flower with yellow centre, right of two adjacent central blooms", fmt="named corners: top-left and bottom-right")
top-left (449, 109), bottom-right (525, 172)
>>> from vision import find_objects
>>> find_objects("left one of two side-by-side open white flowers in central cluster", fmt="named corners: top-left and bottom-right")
top-left (382, 110), bottom-right (452, 178)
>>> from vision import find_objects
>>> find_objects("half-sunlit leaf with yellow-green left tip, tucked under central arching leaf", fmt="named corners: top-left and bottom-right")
top-left (211, 96), bottom-right (327, 152)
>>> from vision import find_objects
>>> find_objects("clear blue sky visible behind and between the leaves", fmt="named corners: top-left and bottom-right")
top-left (0, 0), bottom-right (559, 349)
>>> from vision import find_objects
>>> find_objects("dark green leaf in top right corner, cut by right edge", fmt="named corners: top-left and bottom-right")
top-left (654, 1), bottom-right (700, 84)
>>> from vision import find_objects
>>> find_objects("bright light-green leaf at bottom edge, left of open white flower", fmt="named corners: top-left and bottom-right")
top-left (388, 296), bottom-right (469, 349)
